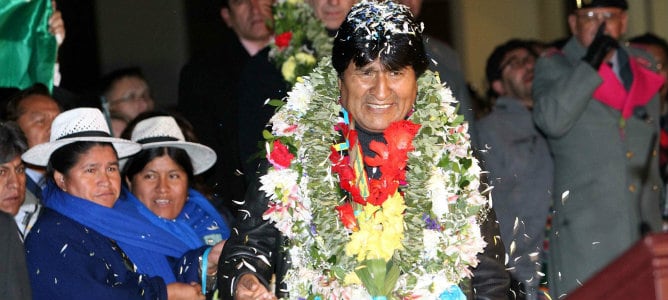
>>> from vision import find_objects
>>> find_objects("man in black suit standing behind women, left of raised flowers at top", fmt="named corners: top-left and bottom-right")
top-left (178, 0), bottom-right (273, 210)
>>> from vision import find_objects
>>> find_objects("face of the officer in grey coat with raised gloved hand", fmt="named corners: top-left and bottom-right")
top-left (568, 7), bottom-right (628, 47)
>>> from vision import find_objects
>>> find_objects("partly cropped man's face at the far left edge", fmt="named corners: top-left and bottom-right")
top-left (0, 156), bottom-right (26, 216)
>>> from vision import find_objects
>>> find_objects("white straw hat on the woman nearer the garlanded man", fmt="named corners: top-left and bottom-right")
top-left (131, 116), bottom-right (216, 175)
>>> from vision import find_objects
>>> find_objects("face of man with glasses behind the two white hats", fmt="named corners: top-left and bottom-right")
top-left (107, 76), bottom-right (155, 120)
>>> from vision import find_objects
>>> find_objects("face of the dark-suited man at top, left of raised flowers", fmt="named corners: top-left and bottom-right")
top-left (220, 0), bottom-right (273, 41)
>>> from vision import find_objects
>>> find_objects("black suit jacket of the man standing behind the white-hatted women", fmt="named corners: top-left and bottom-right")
top-left (178, 33), bottom-right (250, 211)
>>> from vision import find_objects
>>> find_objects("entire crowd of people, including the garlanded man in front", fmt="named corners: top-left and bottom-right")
top-left (0, 0), bottom-right (668, 300)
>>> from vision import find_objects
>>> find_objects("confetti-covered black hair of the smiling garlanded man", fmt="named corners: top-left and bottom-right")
top-left (332, 1), bottom-right (429, 77)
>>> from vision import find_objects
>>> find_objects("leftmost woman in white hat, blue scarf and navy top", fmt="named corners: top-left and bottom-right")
top-left (22, 108), bottom-right (204, 299)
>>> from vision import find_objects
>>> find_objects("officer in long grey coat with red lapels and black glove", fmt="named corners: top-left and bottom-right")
top-left (533, 0), bottom-right (663, 299)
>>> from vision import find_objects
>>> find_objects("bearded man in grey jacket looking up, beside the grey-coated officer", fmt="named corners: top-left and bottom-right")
top-left (476, 39), bottom-right (554, 300)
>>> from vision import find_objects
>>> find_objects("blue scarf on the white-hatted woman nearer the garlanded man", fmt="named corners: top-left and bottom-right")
top-left (114, 189), bottom-right (230, 248)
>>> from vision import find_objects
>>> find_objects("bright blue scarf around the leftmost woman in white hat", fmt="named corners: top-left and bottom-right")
top-left (43, 182), bottom-right (192, 283)
